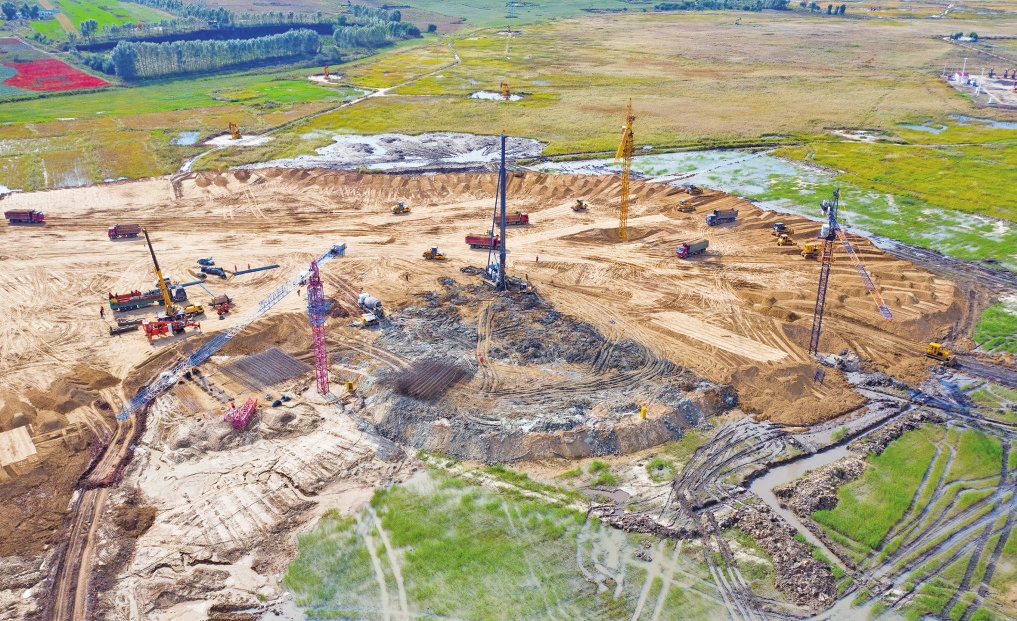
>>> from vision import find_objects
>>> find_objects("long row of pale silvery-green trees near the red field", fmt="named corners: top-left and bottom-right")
top-left (94, 28), bottom-right (320, 79)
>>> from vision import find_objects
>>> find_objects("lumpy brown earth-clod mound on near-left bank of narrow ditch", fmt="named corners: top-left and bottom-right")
top-left (735, 505), bottom-right (837, 610)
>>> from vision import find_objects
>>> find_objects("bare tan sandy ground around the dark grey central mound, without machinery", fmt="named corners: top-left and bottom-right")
top-left (0, 168), bottom-right (970, 618)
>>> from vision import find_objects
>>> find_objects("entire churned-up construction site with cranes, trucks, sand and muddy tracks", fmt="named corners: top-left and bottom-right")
top-left (0, 126), bottom-right (1017, 621)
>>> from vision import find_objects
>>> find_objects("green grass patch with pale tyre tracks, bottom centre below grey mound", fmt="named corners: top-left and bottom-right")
top-left (283, 471), bottom-right (732, 620)
